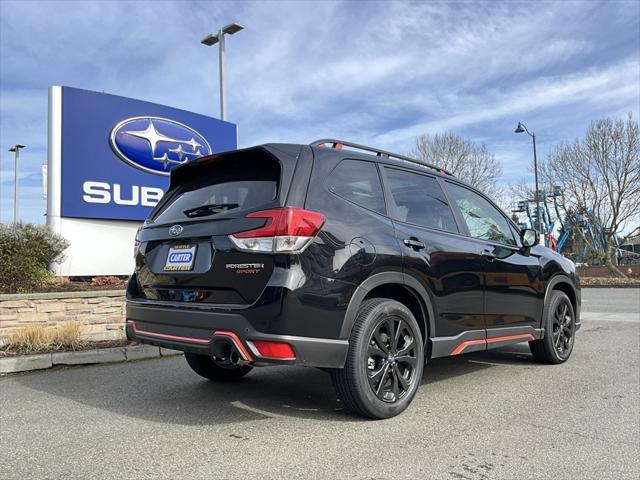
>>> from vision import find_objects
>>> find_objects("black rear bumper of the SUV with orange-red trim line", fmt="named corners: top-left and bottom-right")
top-left (126, 300), bottom-right (349, 368)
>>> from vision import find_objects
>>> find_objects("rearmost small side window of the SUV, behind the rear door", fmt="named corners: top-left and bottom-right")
top-left (327, 160), bottom-right (385, 214)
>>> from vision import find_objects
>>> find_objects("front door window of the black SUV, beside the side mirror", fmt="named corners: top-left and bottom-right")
top-left (447, 182), bottom-right (516, 245)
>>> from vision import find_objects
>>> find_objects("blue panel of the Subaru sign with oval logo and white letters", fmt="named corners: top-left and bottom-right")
top-left (60, 87), bottom-right (237, 221)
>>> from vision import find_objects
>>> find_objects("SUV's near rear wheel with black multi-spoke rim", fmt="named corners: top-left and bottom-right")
top-left (331, 298), bottom-right (424, 419)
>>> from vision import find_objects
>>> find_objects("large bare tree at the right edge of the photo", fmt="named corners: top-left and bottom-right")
top-left (540, 114), bottom-right (640, 276)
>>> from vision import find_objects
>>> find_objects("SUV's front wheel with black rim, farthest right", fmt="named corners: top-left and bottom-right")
top-left (529, 290), bottom-right (576, 364)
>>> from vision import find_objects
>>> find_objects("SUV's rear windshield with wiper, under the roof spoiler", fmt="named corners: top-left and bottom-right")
top-left (153, 156), bottom-right (280, 223)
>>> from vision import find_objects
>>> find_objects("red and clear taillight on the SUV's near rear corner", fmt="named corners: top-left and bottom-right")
top-left (229, 207), bottom-right (324, 253)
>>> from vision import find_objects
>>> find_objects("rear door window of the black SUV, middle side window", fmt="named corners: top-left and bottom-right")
top-left (385, 168), bottom-right (458, 232)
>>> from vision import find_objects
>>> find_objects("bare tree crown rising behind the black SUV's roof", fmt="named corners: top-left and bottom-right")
top-left (412, 132), bottom-right (502, 194)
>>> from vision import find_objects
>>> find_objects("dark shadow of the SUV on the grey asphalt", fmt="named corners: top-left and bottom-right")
top-left (11, 347), bottom-right (531, 425)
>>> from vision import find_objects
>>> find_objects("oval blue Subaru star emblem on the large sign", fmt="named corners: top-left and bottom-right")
top-left (110, 117), bottom-right (212, 175)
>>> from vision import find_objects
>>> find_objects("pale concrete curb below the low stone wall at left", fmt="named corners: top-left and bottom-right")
top-left (0, 344), bottom-right (182, 375)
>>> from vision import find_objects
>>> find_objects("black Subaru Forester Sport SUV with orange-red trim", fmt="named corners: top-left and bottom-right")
top-left (126, 140), bottom-right (580, 418)
